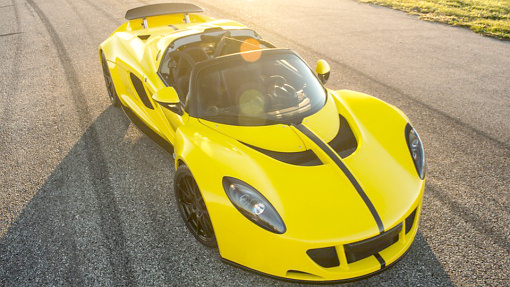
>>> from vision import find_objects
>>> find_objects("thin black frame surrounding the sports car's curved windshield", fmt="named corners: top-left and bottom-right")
top-left (186, 48), bottom-right (328, 126)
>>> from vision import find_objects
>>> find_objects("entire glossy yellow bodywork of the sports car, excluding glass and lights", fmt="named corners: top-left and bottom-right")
top-left (99, 3), bottom-right (425, 281)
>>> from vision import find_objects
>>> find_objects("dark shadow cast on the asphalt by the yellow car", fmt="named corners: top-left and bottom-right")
top-left (0, 107), bottom-right (453, 286)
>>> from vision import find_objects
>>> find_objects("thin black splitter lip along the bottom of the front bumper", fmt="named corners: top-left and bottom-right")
top-left (221, 246), bottom-right (414, 285)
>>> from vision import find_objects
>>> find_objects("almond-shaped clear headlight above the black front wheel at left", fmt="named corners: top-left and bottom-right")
top-left (223, 177), bottom-right (286, 234)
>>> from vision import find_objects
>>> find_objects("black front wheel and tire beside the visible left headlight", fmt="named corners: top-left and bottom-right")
top-left (174, 165), bottom-right (218, 248)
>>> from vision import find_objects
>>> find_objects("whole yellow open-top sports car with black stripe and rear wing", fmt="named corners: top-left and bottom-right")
top-left (99, 3), bottom-right (425, 281)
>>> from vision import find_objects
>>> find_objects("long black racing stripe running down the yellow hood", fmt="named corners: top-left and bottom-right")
top-left (293, 124), bottom-right (384, 233)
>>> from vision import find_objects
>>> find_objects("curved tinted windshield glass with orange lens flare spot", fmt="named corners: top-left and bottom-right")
top-left (197, 51), bottom-right (326, 125)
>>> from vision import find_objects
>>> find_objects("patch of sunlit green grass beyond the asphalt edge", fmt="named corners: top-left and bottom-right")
top-left (358, 0), bottom-right (510, 41)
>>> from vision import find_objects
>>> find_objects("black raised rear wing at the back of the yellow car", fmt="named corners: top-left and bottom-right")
top-left (126, 3), bottom-right (204, 28)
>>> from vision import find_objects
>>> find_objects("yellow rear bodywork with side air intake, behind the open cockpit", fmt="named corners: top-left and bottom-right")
top-left (99, 14), bottom-right (253, 144)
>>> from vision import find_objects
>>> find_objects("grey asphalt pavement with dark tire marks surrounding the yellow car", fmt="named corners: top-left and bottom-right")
top-left (0, 0), bottom-right (510, 286)
